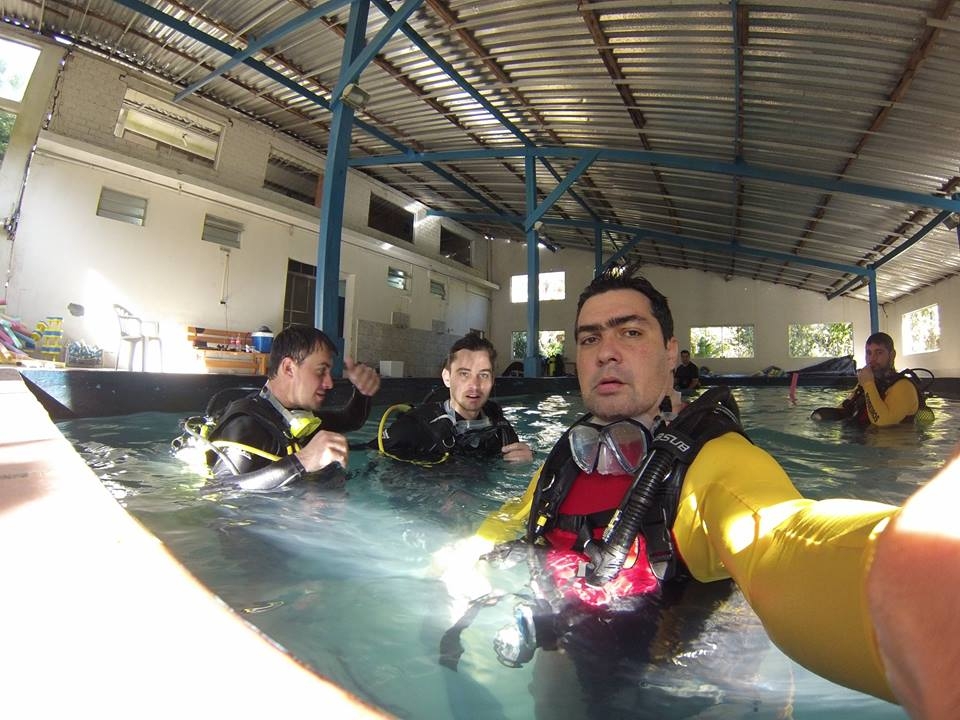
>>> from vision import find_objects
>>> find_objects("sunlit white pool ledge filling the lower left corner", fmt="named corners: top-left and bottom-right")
top-left (0, 368), bottom-right (385, 719)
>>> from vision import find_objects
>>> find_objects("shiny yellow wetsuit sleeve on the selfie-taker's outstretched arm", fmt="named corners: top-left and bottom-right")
top-left (674, 433), bottom-right (897, 702)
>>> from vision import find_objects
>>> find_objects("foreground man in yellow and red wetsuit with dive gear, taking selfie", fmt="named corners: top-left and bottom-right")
top-left (435, 266), bottom-right (916, 714)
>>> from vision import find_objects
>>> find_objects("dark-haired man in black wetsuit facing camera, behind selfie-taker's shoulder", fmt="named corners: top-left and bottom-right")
top-left (373, 333), bottom-right (533, 463)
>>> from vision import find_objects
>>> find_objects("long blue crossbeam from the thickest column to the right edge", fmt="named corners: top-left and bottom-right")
top-left (350, 146), bottom-right (960, 212)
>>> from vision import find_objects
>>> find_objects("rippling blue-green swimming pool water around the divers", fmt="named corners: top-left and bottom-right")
top-left (60, 388), bottom-right (960, 720)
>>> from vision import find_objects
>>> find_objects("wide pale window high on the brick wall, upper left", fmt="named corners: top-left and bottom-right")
top-left (114, 89), bottom-right (223, 167)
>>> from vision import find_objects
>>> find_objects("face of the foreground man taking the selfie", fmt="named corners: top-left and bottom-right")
top-left (576, 290), bottom-right (677, 425)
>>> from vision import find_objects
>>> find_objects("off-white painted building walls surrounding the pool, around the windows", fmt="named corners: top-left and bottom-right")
top-left (0, 32), bottom-right (960, 376)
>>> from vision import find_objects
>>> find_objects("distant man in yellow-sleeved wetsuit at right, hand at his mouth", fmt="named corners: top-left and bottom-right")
top-left (810, 332), bottom-right (924, 427)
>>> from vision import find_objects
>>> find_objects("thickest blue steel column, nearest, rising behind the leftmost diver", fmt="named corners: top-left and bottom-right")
top-left (314, 0), bottom-right (370, 362)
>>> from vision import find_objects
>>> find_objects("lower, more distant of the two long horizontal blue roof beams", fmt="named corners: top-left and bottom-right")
top-left (427, 210), bottom-right (875, 276)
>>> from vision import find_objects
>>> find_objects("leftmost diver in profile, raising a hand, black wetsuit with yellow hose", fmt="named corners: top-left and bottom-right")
top-left (207, 325), bottom-right (380, 490)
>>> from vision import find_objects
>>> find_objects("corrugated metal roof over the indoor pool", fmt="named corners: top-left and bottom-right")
top-left (2, 0), bottom-right (960, 302)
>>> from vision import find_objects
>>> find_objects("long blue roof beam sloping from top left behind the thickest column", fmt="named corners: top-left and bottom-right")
top-left (113, 0), bottom-right (510, 219)
